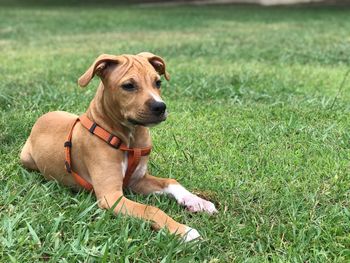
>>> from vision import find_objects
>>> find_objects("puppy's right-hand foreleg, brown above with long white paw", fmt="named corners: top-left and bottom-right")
top-left (131, 174), bottom-right (217, 214)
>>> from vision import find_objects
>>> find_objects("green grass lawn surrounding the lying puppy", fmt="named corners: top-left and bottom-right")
top-left (0, 1), bottom-right (350, 262)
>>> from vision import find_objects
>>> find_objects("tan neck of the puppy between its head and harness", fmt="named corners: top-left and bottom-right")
top-left (86, 82), bottom-right (151, 147)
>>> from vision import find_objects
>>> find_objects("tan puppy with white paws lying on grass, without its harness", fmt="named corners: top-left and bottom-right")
top-left (20, 52), bottom-right (216, 241)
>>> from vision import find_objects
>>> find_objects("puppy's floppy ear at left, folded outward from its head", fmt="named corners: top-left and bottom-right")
top-left (78, 54), bottom-right (119, 87)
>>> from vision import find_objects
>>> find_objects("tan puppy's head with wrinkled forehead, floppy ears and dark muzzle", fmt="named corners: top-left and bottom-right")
top-left (78, 52), bottom-right (169, 126)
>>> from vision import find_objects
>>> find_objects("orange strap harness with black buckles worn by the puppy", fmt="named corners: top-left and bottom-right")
top-left (64, 114), bottom-right (152, 191)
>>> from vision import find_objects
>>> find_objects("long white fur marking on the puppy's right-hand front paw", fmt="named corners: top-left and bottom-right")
top-left (160, 184), bottom-right (217, 214)
